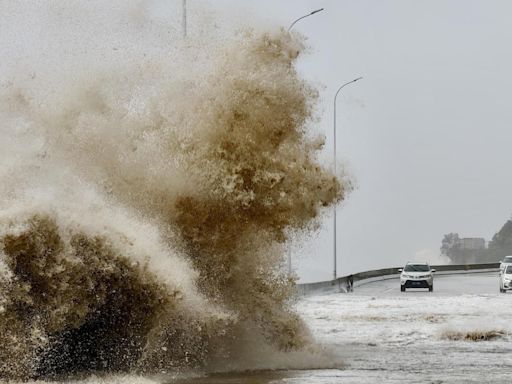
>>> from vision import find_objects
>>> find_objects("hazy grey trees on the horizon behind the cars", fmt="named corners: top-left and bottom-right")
top-left (441, 220), bottom-right (512, 264)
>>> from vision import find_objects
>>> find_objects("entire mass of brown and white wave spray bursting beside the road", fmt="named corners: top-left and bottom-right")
top-left (0, 23), bottom-right (345, 378)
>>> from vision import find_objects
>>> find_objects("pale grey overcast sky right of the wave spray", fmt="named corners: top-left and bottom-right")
top-left (200, 0), bottom-right (512, 281)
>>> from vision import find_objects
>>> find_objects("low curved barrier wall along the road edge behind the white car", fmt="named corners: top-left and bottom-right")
top-left (297, 263), bottom-right (500, 296)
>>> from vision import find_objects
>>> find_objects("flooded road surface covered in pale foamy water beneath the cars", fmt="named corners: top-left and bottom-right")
top-left (173, 273), bottom-right (512, 384)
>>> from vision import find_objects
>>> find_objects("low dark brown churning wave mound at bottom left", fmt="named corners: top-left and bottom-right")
top-left (0, 216), bottom-right (173, 376)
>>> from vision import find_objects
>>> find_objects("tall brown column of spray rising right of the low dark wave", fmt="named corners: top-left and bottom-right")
top-left (170, 33), bottom-right (343, 349)
